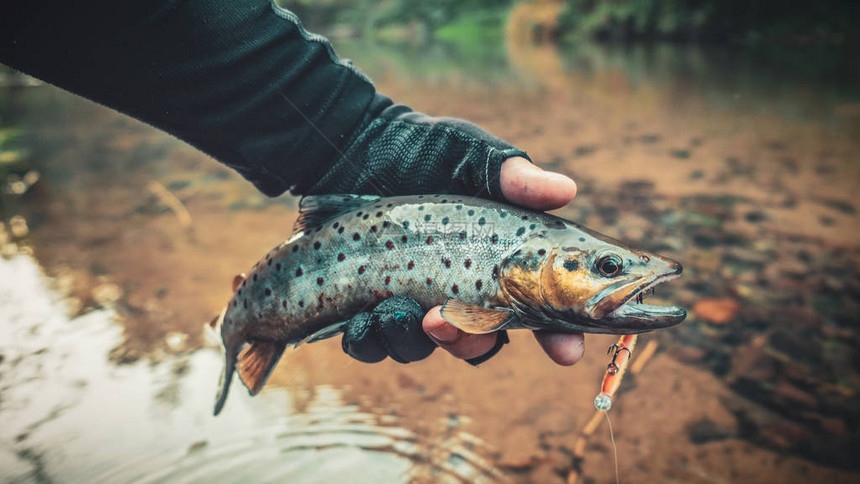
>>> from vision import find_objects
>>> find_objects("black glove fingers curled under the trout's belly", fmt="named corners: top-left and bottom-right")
top-left (341, 296), bottom-right (508, 365)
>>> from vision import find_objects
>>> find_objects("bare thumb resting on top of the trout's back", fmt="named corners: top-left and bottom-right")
top-left (499, 156), bottom-right (576, 210)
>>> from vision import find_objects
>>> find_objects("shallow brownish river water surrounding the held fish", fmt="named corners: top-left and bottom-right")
top-left (0, 37), bottom-right (860, 482)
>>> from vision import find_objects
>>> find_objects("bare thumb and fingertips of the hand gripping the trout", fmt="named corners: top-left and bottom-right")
top-left (422, 156), bottom-right (585, 366)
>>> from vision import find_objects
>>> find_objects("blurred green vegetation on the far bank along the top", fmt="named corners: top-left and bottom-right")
top-left (279, 0), bottom-right (860, 44)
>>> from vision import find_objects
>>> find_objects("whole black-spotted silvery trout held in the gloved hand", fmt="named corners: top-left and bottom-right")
top-left (213, 195), bottom-right (686, 415)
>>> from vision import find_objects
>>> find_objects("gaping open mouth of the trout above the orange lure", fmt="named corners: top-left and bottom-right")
top-left (605, 272), bottom-right (687, 332)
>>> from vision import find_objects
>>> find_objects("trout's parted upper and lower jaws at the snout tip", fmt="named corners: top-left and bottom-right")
top-left (599, 263), bottom-right (687, 334)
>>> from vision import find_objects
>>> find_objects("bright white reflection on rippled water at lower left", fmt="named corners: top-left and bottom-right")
top-left (0, 256), bottom-right (502, 482)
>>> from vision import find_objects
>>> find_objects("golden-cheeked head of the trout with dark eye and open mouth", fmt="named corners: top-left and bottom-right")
top-left (499, 224), bottom-right (687, 334)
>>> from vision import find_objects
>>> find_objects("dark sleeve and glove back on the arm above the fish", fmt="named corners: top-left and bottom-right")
top-left (0, 0), bottom-right (525, 199)
